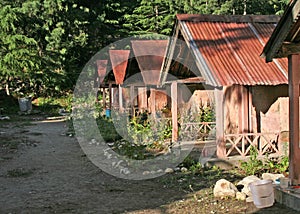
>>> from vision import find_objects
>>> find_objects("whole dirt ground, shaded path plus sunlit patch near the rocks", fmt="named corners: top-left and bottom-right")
top-left (0, 117), bottom-right (295, 214)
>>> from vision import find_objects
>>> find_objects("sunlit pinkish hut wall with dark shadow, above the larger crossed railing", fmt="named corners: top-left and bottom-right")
top-left (224, 85), bottom-right (288, 134)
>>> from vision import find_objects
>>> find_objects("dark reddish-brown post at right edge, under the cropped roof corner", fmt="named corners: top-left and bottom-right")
top-left (288, 54), bottom-right (300, 185)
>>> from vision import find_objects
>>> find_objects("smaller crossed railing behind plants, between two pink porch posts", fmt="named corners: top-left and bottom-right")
top-left (180, 122), bottom-right (216, 141)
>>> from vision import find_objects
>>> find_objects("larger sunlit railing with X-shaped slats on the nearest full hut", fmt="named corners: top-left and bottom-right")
top-left (224, 133), bottom-right (280, 157)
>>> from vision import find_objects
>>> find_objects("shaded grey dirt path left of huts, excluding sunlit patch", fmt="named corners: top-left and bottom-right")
top-left (0, 118), bottom-right (185, 213)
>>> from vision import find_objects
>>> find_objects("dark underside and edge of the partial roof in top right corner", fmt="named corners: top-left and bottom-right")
top-left (262, 0), bottom-right (300, 62)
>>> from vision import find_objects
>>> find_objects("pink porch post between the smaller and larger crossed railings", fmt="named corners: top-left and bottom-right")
top-left (214, 88), bottom-right (226, 158)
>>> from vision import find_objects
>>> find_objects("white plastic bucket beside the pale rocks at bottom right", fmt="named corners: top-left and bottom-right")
top-left (249, 180), bottom-right (274, 208)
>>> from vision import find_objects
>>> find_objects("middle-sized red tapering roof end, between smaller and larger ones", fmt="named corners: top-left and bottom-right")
top-left (109, 50), bottom-right (130, 84)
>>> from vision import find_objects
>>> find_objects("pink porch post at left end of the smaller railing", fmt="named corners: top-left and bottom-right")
top-left (171, 81), bottom-right (178, 142)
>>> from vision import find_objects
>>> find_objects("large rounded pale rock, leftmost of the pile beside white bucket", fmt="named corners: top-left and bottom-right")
top-left (213, 179), bottom-right (238, 197)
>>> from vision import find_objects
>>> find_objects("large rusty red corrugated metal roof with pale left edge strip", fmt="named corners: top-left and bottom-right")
top-left (177, 14), bottom-right (288, 86)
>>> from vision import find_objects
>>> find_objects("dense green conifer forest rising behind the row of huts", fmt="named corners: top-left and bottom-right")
top-left (0, 0), bottom-right (289, 96)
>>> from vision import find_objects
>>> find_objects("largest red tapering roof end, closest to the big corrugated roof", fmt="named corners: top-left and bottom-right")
top-left (131, 40), bottom-right (168, 85)
